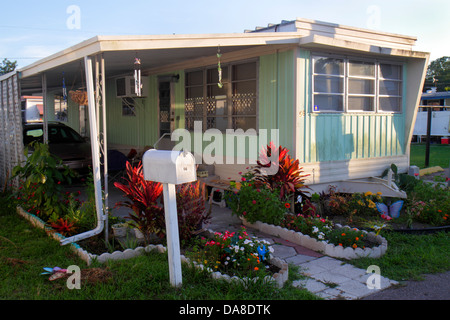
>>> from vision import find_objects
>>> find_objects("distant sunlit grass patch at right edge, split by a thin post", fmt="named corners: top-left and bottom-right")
top-left (410, 143), bottom-right (450, 169)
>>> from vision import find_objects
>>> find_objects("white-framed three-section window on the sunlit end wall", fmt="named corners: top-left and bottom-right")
top-left (312, 56), bottom-right (402, 112)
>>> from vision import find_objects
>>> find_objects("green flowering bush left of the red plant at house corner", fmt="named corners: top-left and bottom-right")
top-left (226, 172), bottom-right (290, 224)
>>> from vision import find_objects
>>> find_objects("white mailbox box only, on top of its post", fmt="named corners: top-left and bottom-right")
top-left (142, 149), bottom-right (197, 185)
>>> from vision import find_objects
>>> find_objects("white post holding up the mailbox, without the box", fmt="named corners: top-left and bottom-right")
top-left (163, 183), bottom-right (182, 287)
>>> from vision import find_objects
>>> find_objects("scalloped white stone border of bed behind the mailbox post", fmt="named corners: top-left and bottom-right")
top-left (17, 207), bottom-right (289, 288)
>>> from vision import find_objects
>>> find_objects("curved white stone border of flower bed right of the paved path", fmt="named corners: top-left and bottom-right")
top-left (242, 219), bottom-right (387, 260)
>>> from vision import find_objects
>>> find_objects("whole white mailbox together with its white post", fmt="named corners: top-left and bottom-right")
top-left (142, 149), bottom-right (197, 287)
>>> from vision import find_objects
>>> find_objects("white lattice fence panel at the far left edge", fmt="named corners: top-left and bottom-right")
top-left (0, 72), bottom-right (24, 190)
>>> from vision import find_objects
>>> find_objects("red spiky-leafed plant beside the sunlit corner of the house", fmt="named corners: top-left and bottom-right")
top-left (255, 142), bottom-right (309, 199)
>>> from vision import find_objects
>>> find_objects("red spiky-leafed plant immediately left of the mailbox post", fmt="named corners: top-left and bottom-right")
top-left (114, 162), bottom-right (165, 241)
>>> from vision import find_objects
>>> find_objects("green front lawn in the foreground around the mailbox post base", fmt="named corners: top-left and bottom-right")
top-left (0, 194), bottom-right (317, 300)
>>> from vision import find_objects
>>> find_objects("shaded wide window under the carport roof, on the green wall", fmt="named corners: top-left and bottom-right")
top-left (185, 62), bottom-right (257, 131)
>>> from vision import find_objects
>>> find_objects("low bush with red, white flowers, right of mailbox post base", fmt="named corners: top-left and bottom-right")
top-left (191, 227), bottom-right (273, 277)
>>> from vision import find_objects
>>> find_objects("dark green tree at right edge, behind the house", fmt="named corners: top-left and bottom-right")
top-left (424, 56), bottom-right (450, 92)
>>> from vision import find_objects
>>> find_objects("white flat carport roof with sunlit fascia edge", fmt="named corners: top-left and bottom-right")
top-left (18, 32), bottom-right (299, 93)
